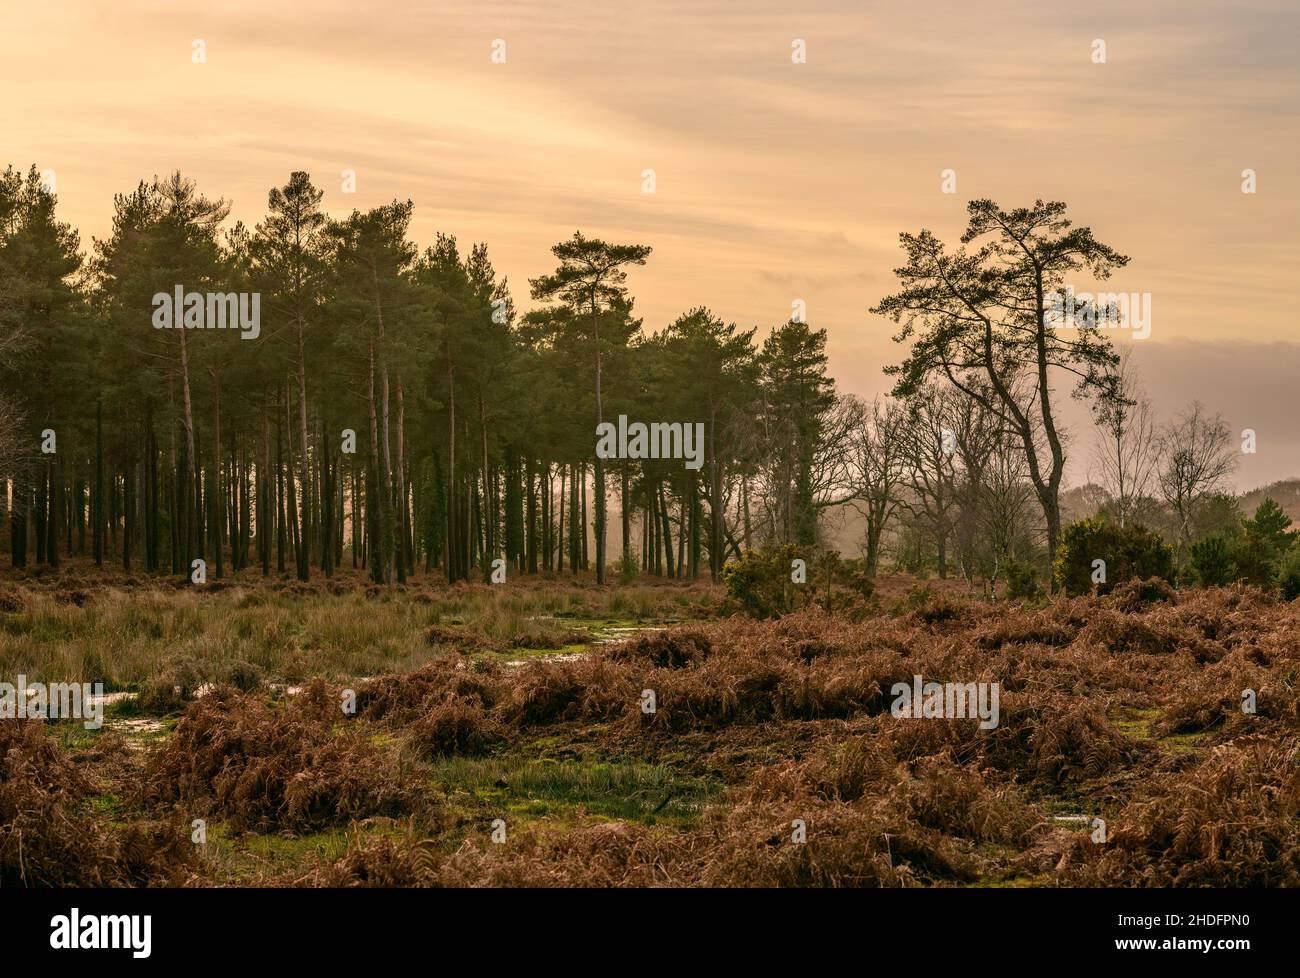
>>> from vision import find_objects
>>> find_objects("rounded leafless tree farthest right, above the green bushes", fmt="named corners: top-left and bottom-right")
top-left (1158, 401), bottom-right (1236, 555)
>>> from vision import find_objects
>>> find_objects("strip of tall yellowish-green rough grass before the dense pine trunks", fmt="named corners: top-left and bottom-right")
top-left (0, 576), bottom-right (715, 691)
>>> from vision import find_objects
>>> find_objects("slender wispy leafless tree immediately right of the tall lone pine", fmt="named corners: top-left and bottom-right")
top-left (1093, 350), bottom-right (1161, 527)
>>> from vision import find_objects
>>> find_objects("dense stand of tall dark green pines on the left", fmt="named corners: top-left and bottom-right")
top-left (0, 166), bottom-right (836, 583)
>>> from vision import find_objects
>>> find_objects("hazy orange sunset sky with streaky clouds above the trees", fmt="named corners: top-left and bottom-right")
top-left (0, 0), bottom-right (1300, 489)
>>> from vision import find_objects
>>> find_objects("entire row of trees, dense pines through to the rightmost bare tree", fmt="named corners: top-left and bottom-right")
top-left (0, 174), bottom-right (1253, 590)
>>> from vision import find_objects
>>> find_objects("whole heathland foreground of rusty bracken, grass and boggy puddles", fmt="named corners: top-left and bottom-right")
top-left (0, 566), bottom-right (1300, 886)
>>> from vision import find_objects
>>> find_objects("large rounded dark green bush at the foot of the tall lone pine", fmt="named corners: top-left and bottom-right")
top-left (1053, 516), bottom-right (1174, 594)
